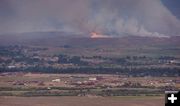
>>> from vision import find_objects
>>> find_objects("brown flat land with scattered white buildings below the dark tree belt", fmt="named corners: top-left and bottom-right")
top-left (0, 72), bottom-right (180, 97)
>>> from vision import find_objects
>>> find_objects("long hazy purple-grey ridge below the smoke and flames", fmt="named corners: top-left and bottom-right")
top-left (0, 32), bottom-right (180, 48)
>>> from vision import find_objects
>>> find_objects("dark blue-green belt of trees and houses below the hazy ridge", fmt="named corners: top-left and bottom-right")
top-left (0, 45), bottom-right (180, 76)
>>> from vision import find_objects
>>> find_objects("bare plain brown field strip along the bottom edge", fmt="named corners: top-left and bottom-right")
top-left (0, 96), bottom-right (164, 106)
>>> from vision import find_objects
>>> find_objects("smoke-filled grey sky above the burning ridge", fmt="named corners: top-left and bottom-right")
top-left (0, 0), bottom-right (180, 37)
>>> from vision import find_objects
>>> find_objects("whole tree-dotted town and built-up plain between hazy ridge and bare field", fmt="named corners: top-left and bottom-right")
top-left (0, 45), bottom-right (180, 96)
